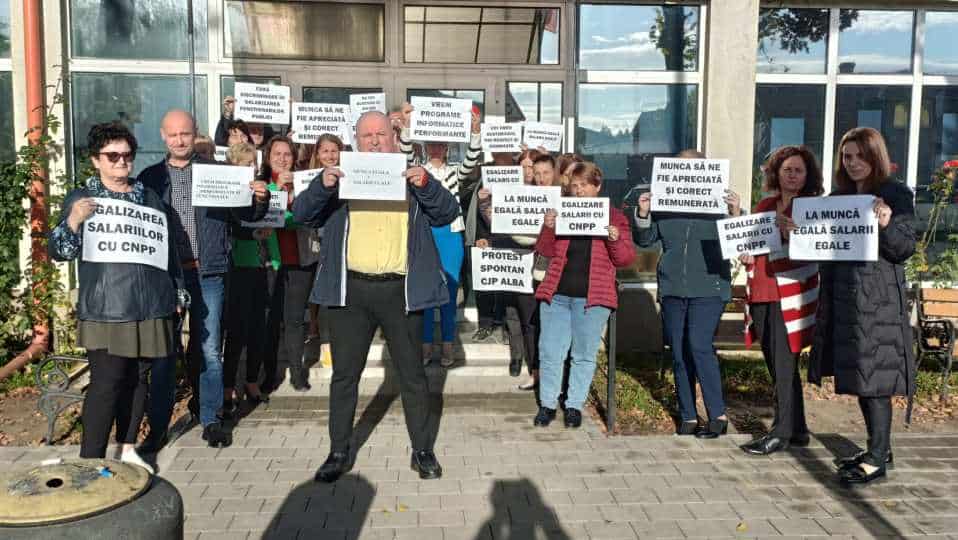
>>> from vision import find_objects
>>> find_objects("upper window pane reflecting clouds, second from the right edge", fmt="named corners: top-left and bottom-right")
top-left (838, 9), bottom-right (915, 73)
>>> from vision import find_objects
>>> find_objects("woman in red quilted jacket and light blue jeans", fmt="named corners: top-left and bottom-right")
top-left (533, 162), bottom-right (635, 428)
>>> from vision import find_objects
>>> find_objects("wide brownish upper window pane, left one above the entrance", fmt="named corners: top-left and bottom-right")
top-left (225, 0), bottom-right (386, 62)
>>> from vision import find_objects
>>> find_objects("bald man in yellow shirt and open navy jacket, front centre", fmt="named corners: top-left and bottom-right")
top-left (293, 112), bottom-right (459, 482)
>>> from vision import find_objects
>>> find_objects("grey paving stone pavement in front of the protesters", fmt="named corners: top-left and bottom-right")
top-left (0, 380), bottom-right (958, 540)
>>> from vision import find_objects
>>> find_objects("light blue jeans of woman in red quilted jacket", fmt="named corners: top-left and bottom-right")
top-left (539, 294), bottom-right (612, 410)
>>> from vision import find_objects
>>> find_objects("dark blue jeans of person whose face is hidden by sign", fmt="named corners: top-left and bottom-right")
top-left (662, 296), bottom-right (725, 422)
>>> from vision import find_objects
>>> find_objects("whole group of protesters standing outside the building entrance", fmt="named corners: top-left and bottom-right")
top-left (49, 87), bottom-right (915, 482)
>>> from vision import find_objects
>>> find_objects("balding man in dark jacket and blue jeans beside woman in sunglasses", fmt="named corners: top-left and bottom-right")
top-left (139, 110), bottom-right (269, 452)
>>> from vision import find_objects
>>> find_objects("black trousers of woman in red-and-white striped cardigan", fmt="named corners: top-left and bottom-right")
top-left (749, 302), bottom-right (808, 439)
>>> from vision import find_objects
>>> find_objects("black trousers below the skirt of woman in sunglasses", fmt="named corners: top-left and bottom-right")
top-left (80, 349), bottom-right (149, 458)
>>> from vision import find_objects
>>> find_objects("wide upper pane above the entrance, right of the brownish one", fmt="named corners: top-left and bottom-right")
top-left (403, 6), bottom-right (560, 64)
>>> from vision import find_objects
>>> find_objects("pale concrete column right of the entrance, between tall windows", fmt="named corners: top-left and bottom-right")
top-left (702, 0), bottom-right (759, 208)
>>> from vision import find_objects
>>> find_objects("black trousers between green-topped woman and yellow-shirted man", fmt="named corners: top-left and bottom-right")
top-left (265, 264), bottom-right (316, 387)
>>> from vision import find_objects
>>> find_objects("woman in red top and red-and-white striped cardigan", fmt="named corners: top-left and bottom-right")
top-left (740, 146), bottom-right (823, 455)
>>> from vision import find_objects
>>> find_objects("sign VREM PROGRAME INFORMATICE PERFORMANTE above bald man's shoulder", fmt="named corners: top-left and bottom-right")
top-left (409, 96), bottom-right (472, 143)
